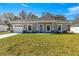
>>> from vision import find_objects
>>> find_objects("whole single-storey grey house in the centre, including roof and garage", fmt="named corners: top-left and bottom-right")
top-left (10, 18), bottom-right (70, 33)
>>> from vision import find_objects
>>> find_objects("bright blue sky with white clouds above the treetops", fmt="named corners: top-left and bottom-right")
top-left (0, 3), bottom-right (79, 20)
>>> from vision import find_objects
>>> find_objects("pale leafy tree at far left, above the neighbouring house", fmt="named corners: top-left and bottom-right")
top-left (0, 13), bottom-right (18, 29)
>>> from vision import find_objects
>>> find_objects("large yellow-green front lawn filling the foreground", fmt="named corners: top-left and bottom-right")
top-left (0, 34), bottom-right (79, 56)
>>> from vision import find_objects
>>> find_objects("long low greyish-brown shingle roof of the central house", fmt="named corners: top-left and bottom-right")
top-left (11, 18), bottom-right (68, 23)
